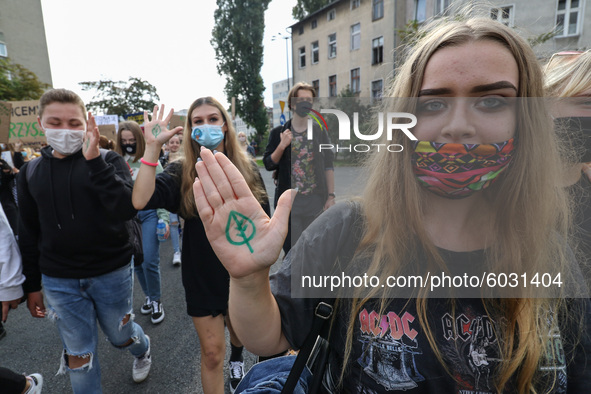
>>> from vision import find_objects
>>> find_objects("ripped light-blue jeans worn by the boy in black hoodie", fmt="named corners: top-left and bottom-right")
top-left (43, 265), bottom-right (148, 394)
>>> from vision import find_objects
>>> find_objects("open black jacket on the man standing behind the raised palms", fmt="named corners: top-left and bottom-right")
top-left (263, 119), bottom-right (334, 206)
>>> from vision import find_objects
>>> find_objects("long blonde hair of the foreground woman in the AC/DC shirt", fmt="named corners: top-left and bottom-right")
top-left (341, 17), bottom-right (572, 392)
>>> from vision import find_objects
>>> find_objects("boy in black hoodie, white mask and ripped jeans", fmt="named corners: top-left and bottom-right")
top-left (17, 89), bottom-right (151, 394)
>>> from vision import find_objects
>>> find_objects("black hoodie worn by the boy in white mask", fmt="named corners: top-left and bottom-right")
top-left (17, 146), bottom-right (136, 293)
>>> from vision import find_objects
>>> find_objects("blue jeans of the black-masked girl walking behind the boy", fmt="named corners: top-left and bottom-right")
top-left (135, 209), bottom-right (162, 301)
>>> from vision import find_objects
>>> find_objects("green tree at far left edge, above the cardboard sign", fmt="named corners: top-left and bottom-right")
top-left (0, 57), bottom-right (50, 101)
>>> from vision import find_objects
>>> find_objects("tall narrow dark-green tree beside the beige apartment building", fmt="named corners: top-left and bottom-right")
top-left (211, 0), bottom-right (270, 135)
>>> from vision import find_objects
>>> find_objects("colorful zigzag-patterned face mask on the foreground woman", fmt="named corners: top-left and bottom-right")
top-left (412, 138), bottom-right (514, 199)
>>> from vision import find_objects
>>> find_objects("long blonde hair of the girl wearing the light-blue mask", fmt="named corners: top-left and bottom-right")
top-left (179, 97), bottom-right (267, 218)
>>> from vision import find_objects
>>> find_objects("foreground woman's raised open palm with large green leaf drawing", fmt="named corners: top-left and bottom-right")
top-left (193, 148), bottom-right (291, 278)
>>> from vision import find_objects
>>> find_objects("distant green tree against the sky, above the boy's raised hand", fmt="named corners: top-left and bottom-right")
top-left (79, 77), bottom-right (160, 116)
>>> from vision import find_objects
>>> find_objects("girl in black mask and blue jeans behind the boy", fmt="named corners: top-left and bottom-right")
top-left (115, 120), bottom-right (170, 324)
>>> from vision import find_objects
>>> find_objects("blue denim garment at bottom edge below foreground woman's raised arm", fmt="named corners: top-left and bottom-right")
top-left (235, 356), bottom-right (312, 394)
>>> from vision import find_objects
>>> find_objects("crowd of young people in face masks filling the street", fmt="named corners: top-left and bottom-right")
top-left (0, 12), bottom-right (591, 394)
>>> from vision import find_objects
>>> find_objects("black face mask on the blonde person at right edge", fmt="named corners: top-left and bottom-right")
top-left (554, 116), bottom-right (591, 163)
